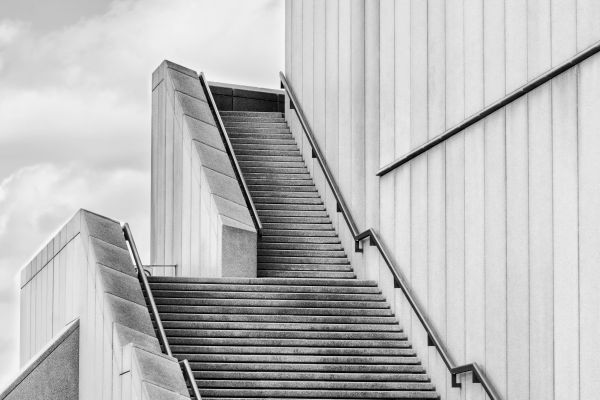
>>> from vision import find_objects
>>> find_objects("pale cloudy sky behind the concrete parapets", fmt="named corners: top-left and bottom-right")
top-left (0, 0), bottom-right (284, 392)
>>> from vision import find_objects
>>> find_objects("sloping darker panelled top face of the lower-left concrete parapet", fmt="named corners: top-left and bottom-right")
top-left (79, 210), bottom-right (189, 399)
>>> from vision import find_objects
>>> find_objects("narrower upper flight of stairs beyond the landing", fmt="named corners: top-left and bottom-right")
top-left (221, 111), bottom-right (356, 279)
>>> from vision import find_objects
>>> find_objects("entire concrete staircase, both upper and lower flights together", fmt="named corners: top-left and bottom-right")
top-left (144, 112), bottom-right (439, 400)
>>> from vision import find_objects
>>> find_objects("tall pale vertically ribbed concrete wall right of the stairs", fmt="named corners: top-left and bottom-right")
top-left (286, 0), bottom-right (600, 399)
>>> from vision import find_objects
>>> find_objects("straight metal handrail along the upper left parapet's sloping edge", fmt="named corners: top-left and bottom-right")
top-left (200, 72), bottom-right (262, 236)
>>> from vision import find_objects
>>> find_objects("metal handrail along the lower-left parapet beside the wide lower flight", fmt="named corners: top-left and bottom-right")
top-left (123, 223), bottom-right (201, 400)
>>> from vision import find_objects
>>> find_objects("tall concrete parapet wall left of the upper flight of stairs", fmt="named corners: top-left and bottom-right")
top-left (151, 61), bottom-right (256, 277)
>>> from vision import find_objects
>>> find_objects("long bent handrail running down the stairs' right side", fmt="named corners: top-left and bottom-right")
top-left (279, 72), bottom-right (500, 400)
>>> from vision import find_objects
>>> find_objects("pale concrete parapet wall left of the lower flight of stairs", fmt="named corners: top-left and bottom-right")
top-left (20, 210), bottom-right (189, 400)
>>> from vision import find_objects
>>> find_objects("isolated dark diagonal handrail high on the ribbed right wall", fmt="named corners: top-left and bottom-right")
top-left (376, 42), bottom-right (600, 176)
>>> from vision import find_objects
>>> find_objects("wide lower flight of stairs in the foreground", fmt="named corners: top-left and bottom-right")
top-left (150, 277), bottom-right (438, 400)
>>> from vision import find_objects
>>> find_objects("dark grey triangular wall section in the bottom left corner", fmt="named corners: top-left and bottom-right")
top-left (0, 320), bottom-right (79, 400)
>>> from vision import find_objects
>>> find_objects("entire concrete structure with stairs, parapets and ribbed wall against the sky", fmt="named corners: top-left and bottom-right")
top-left (0, 0), bottom-right (600, 400)
